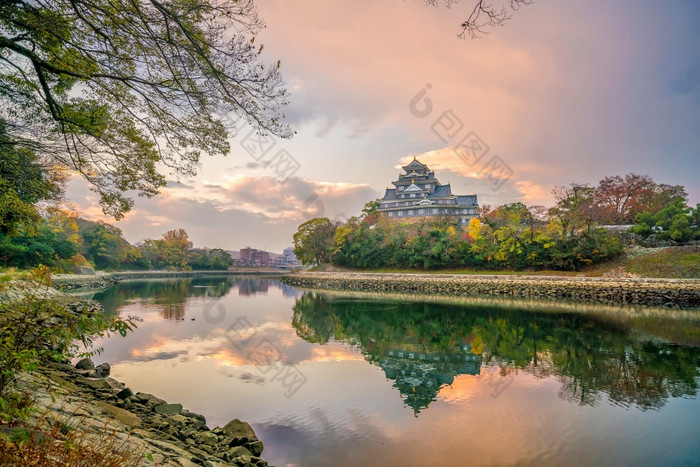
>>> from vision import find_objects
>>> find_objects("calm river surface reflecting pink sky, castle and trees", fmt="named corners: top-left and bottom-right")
top-left (87, 277), bottom-right (700, 466)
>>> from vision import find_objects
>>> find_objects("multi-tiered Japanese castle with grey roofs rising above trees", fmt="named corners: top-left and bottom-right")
top-left (379, 157), bottom-right (479, 225)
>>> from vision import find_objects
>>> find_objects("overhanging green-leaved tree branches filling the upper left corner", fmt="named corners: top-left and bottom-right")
top-left (0, 0), bottom-right (292, 219)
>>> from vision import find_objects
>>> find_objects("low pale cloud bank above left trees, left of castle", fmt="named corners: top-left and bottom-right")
top-left (68, 175), bottom-right (378, 252)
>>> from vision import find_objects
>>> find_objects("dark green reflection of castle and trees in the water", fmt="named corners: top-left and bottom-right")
top-left (292, 292), bottom-right (700, 414)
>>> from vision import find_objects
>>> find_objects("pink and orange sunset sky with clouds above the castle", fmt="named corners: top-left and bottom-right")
top-left (67, 0), bottom-right (700, 252)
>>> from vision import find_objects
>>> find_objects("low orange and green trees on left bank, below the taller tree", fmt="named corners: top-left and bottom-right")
top-left (0, 209), bottom-right (233, 271)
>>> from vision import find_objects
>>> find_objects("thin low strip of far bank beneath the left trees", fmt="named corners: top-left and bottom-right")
top-left (51, 268), bottom-right (289, 290)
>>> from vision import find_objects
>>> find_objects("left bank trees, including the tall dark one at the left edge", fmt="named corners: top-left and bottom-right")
top-left (0, 119), bottom-right (233, 271)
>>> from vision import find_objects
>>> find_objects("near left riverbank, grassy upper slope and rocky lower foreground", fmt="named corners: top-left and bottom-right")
top-left (0, 282), bottom-right (267, 466)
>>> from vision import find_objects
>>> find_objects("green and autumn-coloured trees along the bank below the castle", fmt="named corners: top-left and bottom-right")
top-left (294, 174), bottom-right (700, 270)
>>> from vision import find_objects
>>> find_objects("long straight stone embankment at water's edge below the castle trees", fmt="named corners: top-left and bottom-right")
top-left (281, 272), bottom-right (700, 308)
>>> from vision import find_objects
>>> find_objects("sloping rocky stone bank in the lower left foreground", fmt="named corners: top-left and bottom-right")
top-left (24, 359), bottom-right (267, 466)
